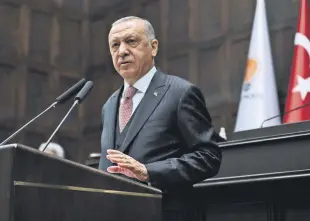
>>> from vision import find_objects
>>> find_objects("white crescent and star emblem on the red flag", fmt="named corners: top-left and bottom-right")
top-left (293, 33), bottom-right (310, 100)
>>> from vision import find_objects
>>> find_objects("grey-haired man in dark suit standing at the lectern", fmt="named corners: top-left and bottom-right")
top-left (99, 17), bottom-right (221, 221)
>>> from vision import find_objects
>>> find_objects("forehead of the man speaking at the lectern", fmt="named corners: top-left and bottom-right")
top-left (109, 20), bottom-right (144, 38)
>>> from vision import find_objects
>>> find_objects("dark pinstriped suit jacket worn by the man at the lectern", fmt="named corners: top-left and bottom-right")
top-left (99, 71), bottom-right (221, 206)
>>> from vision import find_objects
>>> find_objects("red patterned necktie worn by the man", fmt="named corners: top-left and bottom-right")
top-left (119, 86), bottom-right (137, 132)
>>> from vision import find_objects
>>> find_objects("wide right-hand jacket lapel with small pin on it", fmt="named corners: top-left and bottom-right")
top-left (119, 71), bottom-right (169, 152)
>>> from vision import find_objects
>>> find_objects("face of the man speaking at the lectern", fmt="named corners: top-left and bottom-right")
top-left (109, 19), bottom-right (158, 84)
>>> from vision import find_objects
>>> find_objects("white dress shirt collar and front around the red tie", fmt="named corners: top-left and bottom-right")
top-left (122, 66), bottom-right (156, 114)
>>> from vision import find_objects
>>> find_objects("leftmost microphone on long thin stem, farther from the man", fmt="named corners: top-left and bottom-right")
top-left (0, 78), bottom-right (86, 146)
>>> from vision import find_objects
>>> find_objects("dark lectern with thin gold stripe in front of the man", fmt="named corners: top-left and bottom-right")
top-left (0, 144), bottom-right (162, 221)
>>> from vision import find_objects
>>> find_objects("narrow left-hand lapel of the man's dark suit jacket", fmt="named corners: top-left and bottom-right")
top-left (106, 87), bottom-right (123, 149)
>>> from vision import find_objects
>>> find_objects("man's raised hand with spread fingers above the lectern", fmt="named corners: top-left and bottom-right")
top-left (107, 149), bottom-right (149, 182)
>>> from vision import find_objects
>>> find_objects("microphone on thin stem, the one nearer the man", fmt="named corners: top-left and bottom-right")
top-left (41, 81), bottom-right (93, 152)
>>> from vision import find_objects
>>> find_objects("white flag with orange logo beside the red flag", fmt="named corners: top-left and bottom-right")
top-left (235, 0), bottom-right (281, 132)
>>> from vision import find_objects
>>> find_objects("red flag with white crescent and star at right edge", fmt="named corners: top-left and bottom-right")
top-left (283, 0), bottom-right (310, 123)
